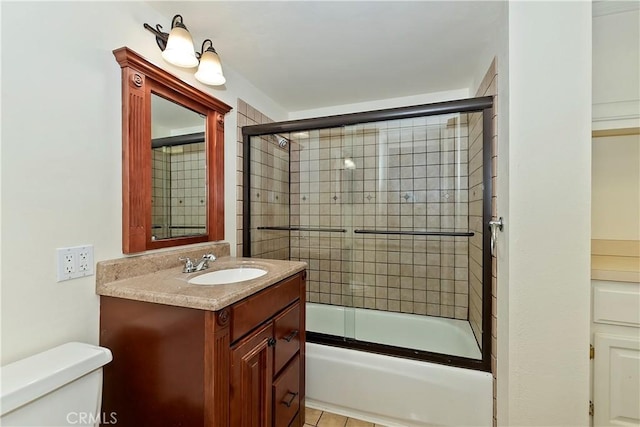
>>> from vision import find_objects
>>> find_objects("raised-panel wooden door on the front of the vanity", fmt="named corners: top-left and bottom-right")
top-left (230, 323), bottom-right (275, 427)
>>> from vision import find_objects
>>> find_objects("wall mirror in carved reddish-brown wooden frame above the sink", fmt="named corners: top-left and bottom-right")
top-left (113, 47), bottom-right (231, 253)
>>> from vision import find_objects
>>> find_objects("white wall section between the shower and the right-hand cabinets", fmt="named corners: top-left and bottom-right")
top-left (498, 2), bottom-right (591, 426)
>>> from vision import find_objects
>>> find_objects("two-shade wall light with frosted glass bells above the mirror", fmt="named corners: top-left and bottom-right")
top-left (144, 15), bottom-right (226, 86)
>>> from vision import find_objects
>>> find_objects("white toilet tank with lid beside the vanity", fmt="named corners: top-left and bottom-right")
top-left (0, 342), bottom-right (112, 427)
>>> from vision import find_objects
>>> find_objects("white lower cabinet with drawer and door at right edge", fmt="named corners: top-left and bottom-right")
top-left (592, 280), bottom-right (640, 427)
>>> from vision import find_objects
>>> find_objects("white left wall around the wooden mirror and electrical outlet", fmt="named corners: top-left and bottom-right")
top-left (1, 2), bottom-right (286, 364)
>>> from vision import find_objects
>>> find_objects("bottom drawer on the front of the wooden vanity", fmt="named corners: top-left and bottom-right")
top-left (273, 356), bottom-right (300, 427)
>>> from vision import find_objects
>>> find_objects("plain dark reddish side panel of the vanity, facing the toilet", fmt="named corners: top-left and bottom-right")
top-left (100, 296), bottom-right (205, 426)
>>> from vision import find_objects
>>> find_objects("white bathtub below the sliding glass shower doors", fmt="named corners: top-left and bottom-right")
top-left (306, 303), bottom-right (493, 426)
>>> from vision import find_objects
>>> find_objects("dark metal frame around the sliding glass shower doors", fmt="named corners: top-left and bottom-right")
top-left (242, 96), bottom-right (493, 372)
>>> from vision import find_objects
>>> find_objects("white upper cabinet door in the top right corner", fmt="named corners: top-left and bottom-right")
top-left (593, 7), bottom-right (640, 130)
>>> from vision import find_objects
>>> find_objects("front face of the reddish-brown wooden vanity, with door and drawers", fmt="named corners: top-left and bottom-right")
top-left (230, 277), bottom-right (304, 427)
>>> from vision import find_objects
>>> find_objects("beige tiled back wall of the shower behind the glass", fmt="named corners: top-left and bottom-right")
top-left (291, 114), bottom-right (469, 319)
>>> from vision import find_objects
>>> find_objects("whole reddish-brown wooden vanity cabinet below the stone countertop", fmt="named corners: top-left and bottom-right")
top-left (100, 271), bottom-right (306, 427)
